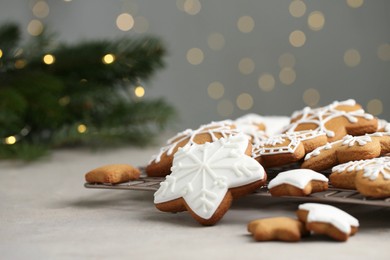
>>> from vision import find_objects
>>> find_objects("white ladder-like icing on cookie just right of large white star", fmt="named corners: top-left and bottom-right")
top-left (252, 130), bottom-right (325, 158)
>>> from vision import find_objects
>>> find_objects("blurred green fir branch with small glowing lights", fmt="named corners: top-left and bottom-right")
top-left (0, 23), bottom-right (175, 160)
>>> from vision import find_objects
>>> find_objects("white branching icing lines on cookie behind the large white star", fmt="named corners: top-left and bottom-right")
top-left (149, 120), bottom-right (237, 163)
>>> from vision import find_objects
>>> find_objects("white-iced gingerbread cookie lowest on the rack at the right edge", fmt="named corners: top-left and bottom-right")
top-left (329, 156), bottom-right (390, 198)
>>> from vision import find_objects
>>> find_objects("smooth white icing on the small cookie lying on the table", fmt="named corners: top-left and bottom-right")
top-left (298, 203), bottom-right (359, 234)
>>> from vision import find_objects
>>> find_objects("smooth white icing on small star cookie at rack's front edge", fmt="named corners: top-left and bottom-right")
top-left (268, 169), bottom-right (328, 189)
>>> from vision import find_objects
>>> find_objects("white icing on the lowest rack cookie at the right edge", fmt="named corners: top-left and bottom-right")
top-left (332, 157), bottom-right (390, 181)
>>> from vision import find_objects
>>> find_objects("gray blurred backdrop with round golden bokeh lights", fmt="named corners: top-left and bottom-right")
top-left (0, 0), bottom-right (390, 129)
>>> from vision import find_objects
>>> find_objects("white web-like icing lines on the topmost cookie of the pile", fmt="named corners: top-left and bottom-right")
top-left (286, 99), bottom-right (374, 137)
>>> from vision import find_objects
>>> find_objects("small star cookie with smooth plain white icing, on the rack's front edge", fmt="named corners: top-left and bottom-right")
top-left (268, 169), bottom-right (328, 196)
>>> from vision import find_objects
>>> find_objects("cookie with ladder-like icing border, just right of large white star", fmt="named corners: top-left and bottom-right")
top-left (252, 130), bottom-right (327, 168)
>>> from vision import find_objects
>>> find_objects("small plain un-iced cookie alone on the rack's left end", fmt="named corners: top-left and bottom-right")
top-left (85, 164), bottom-right (141, 184)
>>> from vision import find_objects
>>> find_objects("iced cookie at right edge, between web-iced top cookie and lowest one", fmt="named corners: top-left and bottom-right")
top-left (302, 132), bottom-right (390, 171)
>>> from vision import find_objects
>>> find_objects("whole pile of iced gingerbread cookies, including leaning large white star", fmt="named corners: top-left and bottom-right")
top-left (84, 100), bottom-right (390, 232)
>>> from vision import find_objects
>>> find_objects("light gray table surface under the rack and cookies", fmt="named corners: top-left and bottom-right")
top-left (0, 144), bottom-right (390, 260)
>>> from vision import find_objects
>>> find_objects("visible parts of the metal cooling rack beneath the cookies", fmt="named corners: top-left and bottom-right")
top-left (84, 165), bottom-right (390, 207)
